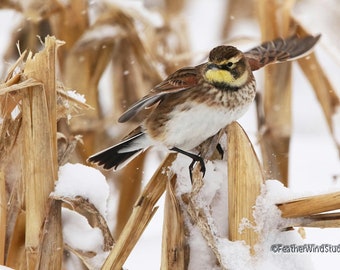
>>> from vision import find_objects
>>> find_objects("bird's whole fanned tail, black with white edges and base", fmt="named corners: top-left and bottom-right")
top-left (87, 132), bottom-right (149, 170)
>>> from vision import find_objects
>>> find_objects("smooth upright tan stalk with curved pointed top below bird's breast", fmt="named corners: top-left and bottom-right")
top-left (227, 122), bottom-right (263, 251)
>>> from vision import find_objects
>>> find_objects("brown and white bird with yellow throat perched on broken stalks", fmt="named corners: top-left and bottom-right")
top-left (88, 35), bottom-right (320, 179)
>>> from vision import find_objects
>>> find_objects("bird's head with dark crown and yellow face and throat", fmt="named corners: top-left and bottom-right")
top-left (204, 46), bottom-right (252, 89)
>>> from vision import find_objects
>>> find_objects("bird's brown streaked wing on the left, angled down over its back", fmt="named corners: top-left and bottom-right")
top-left (118, 66), bottom-right (200, 123)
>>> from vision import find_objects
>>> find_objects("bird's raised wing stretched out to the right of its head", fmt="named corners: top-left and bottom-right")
top-left (244, 35), bottom-right (321, 71)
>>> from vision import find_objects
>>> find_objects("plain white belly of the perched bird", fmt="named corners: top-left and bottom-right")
top-left (159, 103), bottom-right (249, 150)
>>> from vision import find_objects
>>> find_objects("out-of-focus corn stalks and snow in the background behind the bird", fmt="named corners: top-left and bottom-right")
top-left (0, 0), bottom-right (340, 269)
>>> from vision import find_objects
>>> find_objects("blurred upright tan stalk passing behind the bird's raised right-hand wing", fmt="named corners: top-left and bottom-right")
top-left (257, 0), bottom-right (294, 186)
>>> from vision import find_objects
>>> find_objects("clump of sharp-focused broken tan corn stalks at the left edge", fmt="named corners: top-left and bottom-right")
top-left (0, 34), bottom-right (93, 269)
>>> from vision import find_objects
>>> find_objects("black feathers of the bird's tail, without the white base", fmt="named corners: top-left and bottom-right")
top-left (87, 134), bottom-right (143, 170)
